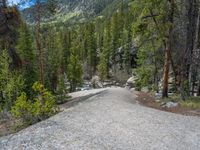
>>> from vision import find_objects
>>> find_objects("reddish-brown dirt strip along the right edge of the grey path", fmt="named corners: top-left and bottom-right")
top-left (136, 92), bottom-right (200, 117)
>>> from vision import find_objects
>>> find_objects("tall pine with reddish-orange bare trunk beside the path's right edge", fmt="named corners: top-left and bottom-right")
top-left (133, 0), bottom-right (175, 98)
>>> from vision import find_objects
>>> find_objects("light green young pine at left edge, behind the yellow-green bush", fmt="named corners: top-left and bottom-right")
top-left (0, 50), bottom-right (24, 111)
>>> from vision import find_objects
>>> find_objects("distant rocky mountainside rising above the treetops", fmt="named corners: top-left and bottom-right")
top-left (19, 0), bottom-right (130, 22)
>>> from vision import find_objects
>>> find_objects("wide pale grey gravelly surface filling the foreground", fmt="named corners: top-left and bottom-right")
top-left (0, 88), bottom-right (200, 150)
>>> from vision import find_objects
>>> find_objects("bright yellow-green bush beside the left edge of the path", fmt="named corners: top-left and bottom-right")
top-left (11, 82), bottom-right (58, 124)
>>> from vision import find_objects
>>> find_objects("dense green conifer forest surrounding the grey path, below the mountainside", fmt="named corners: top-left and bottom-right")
top-left (0, 0), bottom-right (200, 123)
